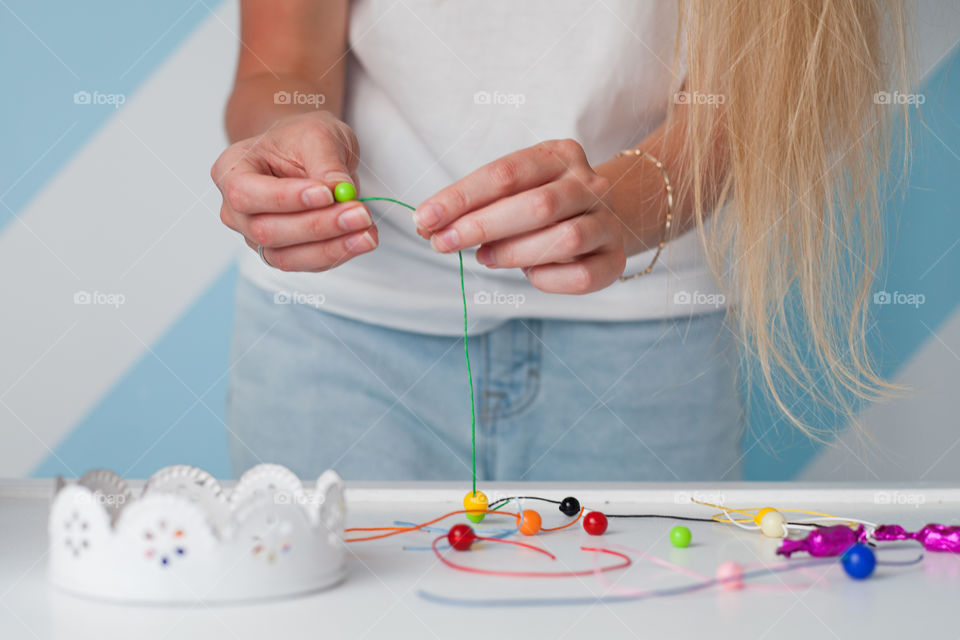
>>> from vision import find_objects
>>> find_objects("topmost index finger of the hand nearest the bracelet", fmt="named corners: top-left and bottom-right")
top-left (415, 140), bottom-right (585, 230)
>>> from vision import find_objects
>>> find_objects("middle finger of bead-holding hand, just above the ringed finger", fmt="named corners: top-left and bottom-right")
top-left (238, 202), bottom-right (373, 248)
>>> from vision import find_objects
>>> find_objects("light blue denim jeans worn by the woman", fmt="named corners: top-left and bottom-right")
top-left (227, 278), bottom-right (743, 481)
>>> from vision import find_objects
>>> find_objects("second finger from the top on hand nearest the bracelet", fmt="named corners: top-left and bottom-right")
top-left (430, 177), bottom-right (597, 253)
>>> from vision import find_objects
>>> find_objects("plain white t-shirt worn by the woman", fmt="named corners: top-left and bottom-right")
top-left (241, 0), bottom-right (717, 335)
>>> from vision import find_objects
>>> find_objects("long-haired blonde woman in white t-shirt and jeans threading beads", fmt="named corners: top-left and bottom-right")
top-left (212, 0), bottom-right (903, 480)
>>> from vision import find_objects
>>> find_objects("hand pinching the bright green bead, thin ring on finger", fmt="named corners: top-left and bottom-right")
top-left (210, 111), bottom-right (378, 272)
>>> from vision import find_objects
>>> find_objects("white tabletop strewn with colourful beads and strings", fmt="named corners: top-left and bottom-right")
top-left (0, 481), bottom-right (960, 640)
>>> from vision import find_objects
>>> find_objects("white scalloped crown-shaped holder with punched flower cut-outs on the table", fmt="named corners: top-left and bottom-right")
top-left (49, 464), bottom-right (346, 603)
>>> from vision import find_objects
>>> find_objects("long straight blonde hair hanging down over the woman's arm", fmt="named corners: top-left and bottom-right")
top-left (678, 0), bottom-right (909, 438)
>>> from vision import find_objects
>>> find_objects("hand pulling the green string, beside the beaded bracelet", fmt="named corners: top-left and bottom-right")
top-left (416, 140), bottom-right (626, 293)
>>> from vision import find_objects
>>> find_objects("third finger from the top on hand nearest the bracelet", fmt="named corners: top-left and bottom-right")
top-left (477, 213), bottom-right (614, 269)
